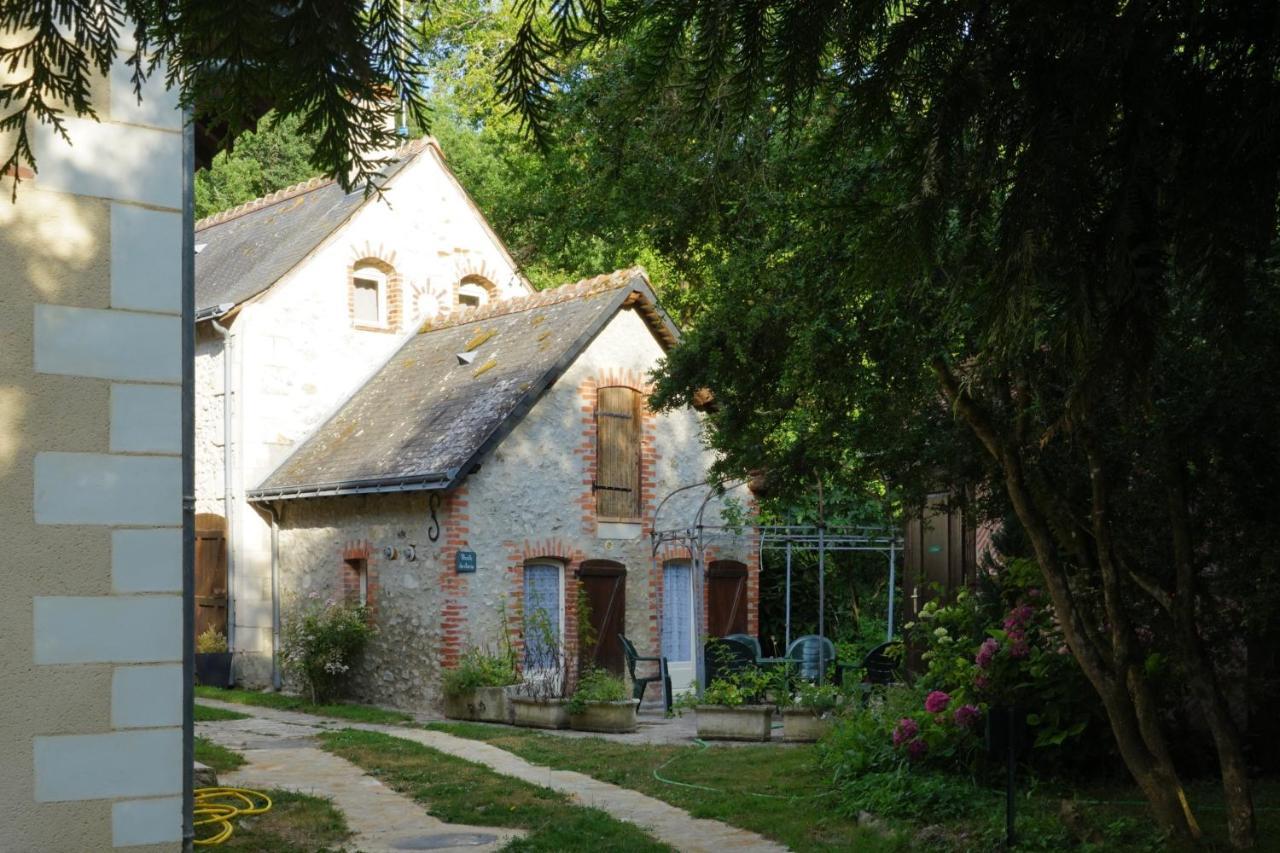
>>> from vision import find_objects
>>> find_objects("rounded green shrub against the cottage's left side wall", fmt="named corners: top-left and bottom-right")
top-left (280, 593), bottom-right (374, 703)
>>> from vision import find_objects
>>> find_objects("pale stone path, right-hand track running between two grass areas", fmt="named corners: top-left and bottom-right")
top-left (197, 699), bottom-right (787, 853)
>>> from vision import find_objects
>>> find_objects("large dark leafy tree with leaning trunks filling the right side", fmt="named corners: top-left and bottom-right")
top-left (498, 0), bottom-right (1280, 847)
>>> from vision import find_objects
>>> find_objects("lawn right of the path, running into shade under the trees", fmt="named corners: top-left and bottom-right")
top-left (426, 722), bottom-right (1280, 853)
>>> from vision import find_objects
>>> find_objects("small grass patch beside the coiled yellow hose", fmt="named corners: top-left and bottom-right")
top-left (209, 790), bottom-right (351, 853)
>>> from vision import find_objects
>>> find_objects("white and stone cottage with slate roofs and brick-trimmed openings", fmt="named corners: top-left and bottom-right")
top-left (196, 140), bottom-right (758, 708)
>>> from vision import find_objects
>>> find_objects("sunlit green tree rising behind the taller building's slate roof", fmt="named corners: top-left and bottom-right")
top-left (196, 113), bottom-right (320, 219)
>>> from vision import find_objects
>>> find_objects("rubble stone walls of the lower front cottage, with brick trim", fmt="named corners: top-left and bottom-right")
top-left (270, 302), bottom-right (758, 708)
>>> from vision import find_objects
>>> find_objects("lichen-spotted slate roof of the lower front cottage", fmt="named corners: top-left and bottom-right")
top-left (248, 268), bottom-right (678, 501)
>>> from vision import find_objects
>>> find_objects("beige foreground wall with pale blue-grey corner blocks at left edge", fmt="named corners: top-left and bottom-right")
top-left (0, 48), bottom-right (186, 850)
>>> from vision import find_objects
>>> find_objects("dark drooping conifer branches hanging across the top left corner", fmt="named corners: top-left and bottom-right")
top-left (0, 0), bottom-right (425, 192)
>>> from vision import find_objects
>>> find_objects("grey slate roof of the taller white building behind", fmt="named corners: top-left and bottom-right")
top-left (196, 138), bottom-right (433, 313)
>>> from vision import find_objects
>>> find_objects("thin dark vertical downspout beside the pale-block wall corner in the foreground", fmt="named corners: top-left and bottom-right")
top-left (179, 108), bottom-right (196, 853)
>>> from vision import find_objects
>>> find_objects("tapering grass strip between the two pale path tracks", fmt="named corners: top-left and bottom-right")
top-left (320, 729), bottom-right (671, 853)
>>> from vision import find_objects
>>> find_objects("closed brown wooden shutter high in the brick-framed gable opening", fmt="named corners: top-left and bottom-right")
top-left (594, 388), bottom-right (640, 519)
